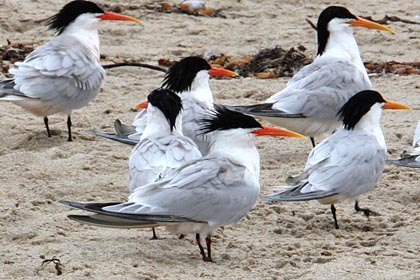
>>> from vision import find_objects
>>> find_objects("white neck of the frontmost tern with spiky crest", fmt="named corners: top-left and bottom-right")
top-left (207, 129), bottom-right (260, 179)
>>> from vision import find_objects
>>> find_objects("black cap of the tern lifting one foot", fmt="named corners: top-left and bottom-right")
top-left (337, 90), bottom-right (386, 130)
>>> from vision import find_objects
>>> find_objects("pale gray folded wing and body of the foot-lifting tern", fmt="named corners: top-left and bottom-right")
top-left (265, 129), bottom-right (386, 201)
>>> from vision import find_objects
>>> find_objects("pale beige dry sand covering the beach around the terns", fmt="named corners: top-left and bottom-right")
top-left (0, 0), bottom-right (420, 279)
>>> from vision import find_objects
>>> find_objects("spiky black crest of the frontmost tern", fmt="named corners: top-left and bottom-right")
top-left (201, 105), bottom-right (262, 133)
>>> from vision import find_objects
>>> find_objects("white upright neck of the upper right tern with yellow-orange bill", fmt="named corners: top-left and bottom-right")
top-left (317, 25), bottom-right (369, 77)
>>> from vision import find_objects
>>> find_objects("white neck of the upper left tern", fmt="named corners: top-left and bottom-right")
top-left (59, 14), bottom-right (100, 61)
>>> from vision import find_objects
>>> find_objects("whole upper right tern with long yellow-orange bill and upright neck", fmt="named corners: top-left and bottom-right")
top-left (228, 6), bottom-right (395, 146)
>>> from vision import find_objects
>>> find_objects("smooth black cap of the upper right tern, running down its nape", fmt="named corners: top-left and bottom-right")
top-left (316, 6), bottom-right (356, 55)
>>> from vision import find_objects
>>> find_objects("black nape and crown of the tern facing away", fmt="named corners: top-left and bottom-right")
top-left (147, 88), bottom-right (182, 131)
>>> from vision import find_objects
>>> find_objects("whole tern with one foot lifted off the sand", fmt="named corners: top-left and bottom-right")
top-left (263, 90), bottom-right (410, 229)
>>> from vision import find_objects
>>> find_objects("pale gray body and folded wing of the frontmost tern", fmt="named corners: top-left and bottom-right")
top-left (104, 157), bottom-right (259, 225)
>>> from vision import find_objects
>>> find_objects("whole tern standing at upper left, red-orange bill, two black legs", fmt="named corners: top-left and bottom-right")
top-left (0, 0), bottom-right (140, 141)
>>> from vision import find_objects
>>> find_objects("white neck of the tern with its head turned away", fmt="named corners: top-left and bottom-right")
top-left (140, 106), bottom-right (182, 140)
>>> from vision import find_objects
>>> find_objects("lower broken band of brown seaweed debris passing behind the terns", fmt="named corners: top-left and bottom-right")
top-left (0, 41), bottom-right (420, 79)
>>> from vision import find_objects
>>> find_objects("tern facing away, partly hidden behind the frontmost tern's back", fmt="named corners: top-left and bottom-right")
top-left (128, 89), bottom-right (202, 239)
